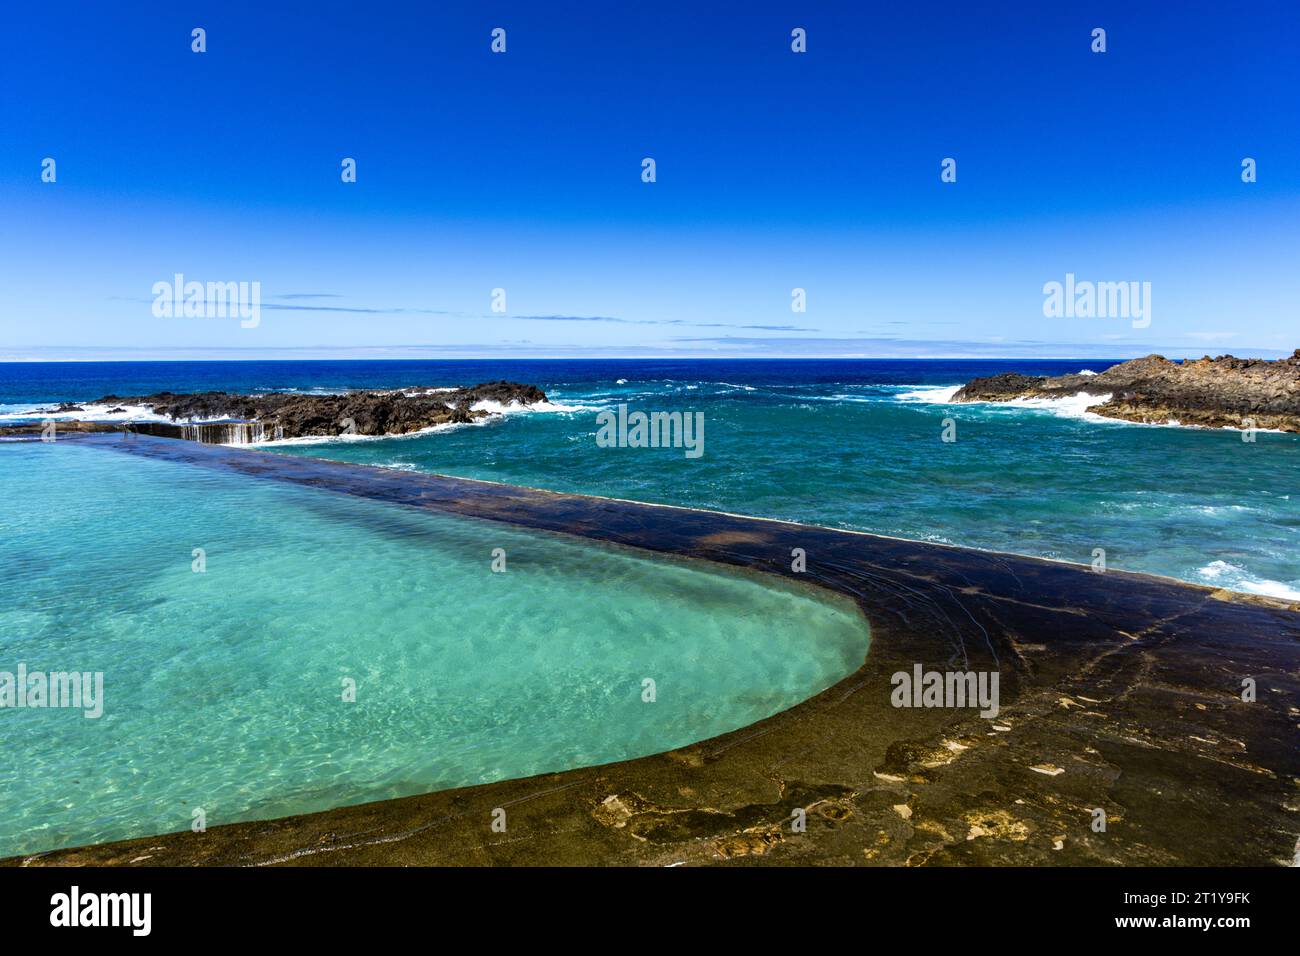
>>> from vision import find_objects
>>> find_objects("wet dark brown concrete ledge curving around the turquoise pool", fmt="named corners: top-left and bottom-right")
top-left (4, 434), bottom-right (1300, 866)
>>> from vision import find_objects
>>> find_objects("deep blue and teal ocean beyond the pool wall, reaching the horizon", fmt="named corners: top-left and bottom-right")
top-left (0, 359), bottom-right (1300, 600)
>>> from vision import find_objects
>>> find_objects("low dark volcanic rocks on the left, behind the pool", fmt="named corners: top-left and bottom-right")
top-left (59, 381), bottom-right (546, 442)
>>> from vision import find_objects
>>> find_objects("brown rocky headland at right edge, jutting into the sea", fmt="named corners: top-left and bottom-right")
top-left (953, 349), bottom-right (1300, 432)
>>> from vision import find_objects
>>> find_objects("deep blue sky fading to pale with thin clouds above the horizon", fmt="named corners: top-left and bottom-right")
top-left (0, 1), bottom-right (1300, 359)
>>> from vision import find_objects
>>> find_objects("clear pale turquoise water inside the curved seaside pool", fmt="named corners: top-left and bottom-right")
top-left (0, 441), bottom-right (867, 856)
